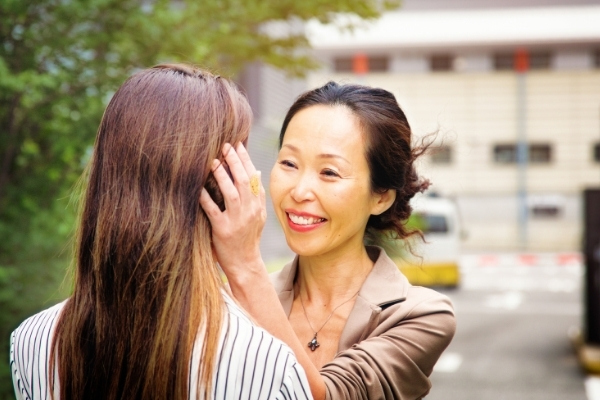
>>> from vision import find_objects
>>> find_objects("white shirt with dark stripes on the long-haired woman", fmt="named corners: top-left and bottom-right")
top-left (10, 295), bottom-right (312, 400)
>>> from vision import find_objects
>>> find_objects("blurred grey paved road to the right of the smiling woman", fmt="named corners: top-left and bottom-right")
top-left (427, 254), bottom-right (597, 400)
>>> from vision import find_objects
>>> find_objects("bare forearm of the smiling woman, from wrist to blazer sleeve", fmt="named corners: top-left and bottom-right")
top-left (228, 260), bottom-right (325, 400)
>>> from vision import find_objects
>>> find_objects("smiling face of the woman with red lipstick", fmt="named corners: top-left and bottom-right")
top-left (270, 105), bottom-right (387, 256)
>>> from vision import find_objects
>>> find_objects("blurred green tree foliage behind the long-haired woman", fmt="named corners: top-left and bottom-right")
top-left (0, 0), bottom-right (399, 399)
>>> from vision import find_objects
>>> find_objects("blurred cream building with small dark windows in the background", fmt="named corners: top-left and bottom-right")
top-left (241, 0), bottom-right (600, 251)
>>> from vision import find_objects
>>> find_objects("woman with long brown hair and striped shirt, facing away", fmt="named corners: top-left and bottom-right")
top-left (11, 65), bottom-right (310, 400)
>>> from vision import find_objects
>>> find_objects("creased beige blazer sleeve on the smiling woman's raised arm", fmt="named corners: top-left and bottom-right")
top-left (321, 288), bottom-right (456, 400)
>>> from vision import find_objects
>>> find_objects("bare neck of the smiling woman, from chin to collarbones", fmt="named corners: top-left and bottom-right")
top-left (295, 244), bottom-right (373, 309)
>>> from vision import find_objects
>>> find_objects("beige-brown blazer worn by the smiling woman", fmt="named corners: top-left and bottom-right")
top-left (271, 247), bottom-right (456, 400)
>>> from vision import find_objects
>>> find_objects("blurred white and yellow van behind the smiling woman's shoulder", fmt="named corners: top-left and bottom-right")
top-left (394, 195), bottom-right (461, 287)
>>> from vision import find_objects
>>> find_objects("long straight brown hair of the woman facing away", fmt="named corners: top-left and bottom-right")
top-left (50, 64), bottom-right (252, 400)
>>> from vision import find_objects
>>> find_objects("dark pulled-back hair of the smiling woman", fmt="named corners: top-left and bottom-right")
top-left (279, 82), bottom-right (429, 242)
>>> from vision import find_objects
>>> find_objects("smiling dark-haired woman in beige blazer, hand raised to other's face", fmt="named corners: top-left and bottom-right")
top-left (202, 82), bottom-right (455, 399)
